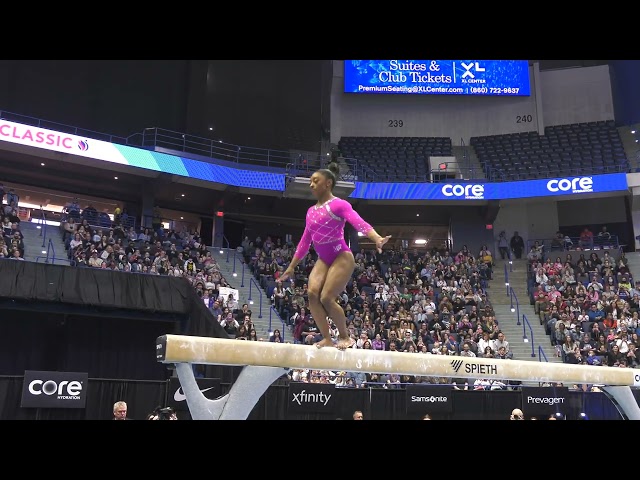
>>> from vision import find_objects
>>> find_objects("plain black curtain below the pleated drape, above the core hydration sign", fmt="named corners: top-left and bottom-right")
top-left (0, 309), bottom-right (178, 380)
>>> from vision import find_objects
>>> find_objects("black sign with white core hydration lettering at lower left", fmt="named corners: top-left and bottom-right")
top-left (20, 370), bottom-right (89, 408)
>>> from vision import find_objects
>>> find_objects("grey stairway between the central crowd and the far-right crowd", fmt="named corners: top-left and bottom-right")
top-left (488, 259), bottom-right (561, 363)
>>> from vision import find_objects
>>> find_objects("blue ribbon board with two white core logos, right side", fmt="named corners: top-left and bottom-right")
top-left (349, 173), bottom-right (628, 200)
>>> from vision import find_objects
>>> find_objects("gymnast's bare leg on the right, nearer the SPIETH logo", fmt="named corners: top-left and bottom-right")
top-left (318, 249), bottom-right (356, 350)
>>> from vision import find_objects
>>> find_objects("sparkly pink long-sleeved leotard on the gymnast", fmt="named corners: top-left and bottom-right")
top-left (293, 197), bottom-right (373, 265)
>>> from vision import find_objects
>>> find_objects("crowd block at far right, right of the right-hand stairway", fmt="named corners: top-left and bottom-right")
top-left (528, 238), bottom-right (640, 368)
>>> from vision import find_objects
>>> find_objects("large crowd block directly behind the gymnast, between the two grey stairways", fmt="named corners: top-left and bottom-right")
top-left (242, 236), bottom-right (519, 390)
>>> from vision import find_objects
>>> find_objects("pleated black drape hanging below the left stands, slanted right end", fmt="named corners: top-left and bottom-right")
top-left (0, 260), bottom-right (228, 341)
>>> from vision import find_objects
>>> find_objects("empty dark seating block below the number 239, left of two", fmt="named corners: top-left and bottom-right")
top-left (338, 137), bottom-right (452, 181)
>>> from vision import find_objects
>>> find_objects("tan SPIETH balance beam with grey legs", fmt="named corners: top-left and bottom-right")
top-left (156, 335), bottom-right (640, 419)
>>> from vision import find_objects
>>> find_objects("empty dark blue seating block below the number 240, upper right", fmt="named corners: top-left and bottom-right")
top-left (469, 120), bottom-right (629, 180)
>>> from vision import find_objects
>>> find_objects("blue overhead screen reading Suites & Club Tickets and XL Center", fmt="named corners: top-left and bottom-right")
top-left (344, 60), bottom-right (531, 96)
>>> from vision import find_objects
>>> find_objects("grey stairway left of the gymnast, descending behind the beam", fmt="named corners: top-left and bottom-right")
top-left (209, 247), bottom-right (284, 341)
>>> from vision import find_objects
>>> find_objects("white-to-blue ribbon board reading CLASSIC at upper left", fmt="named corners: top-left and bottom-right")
top-left (0, 120), bottom-right (285, 191)
